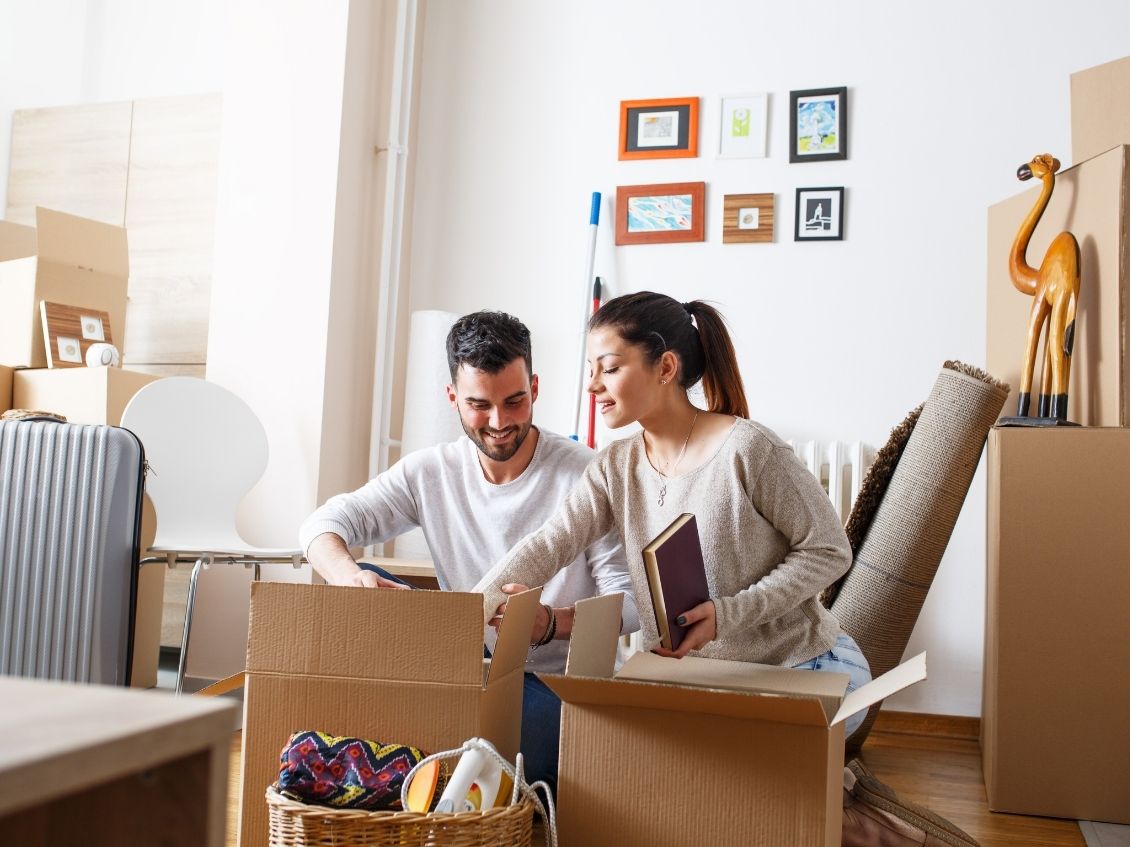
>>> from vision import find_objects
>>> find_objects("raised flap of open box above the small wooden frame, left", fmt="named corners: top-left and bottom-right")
top-left (35, 208), bottom-right (130, 278)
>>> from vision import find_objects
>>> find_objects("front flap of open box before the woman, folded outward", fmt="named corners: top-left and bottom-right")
top-left (538, 673), bottom-right (828, 726)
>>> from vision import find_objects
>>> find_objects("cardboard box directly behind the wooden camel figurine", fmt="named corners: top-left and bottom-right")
top-left (985, 147), bottom-right (1130, 427)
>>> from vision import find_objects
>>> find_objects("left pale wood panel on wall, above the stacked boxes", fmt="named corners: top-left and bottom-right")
top-left (6, 102), bottom-right (133, 226)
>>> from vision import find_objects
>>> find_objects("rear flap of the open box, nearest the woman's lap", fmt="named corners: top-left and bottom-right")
top-left (616, 653), bottom-right (850, 722)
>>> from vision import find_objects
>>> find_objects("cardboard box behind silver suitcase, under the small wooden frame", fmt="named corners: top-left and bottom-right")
top-left (13, 368), bottom-right (165, 688)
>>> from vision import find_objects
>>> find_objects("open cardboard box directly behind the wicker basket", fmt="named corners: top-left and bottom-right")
top-left (240, 583), bottom-right (541, 847)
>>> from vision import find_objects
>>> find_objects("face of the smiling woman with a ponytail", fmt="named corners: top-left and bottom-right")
top-left (588, 326), bottom-right (662, 429)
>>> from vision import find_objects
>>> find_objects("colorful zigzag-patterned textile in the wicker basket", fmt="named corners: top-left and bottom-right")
top-left (276, 730), bottom-right (443, 811)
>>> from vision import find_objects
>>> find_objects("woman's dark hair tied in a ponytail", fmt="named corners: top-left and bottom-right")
top-left (589, 291), bottom-right (749, 418)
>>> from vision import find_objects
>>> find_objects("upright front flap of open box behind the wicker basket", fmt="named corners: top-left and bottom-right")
top-left (247, 582), bottom-right (483, 688)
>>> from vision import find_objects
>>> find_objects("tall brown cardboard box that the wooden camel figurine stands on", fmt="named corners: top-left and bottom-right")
top-left (981, 428), bottom-right (1130, 823)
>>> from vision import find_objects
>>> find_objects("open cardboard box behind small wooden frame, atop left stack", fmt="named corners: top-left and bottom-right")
top-left (0, 208), bottom-right (130, 368)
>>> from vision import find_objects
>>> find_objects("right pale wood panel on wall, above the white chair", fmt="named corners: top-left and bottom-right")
top-left (124, 94), bottom-right (220, 365)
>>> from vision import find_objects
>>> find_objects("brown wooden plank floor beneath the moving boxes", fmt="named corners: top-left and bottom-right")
top-left (227, 713), bottom-right (1086, 847)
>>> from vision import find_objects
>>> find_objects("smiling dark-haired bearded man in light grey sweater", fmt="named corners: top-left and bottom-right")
top-left (299, 312), bottom-right (640, 788)
